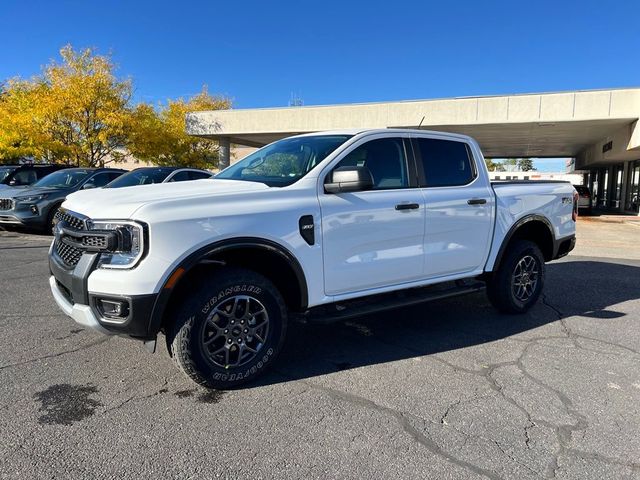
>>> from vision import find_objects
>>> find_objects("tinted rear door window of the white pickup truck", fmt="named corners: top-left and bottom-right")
top-left (417, 138), bottom-right (475, 187)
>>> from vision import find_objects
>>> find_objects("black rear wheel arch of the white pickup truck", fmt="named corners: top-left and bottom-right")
top-left (491, 214), bottom-right (557, 271)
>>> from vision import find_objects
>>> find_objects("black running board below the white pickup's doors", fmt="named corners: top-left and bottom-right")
top-left (292, 281), bottom-right (485, 324)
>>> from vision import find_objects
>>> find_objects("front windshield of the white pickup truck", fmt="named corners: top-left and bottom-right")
top-left (215, 135), bottom-right (351, 187)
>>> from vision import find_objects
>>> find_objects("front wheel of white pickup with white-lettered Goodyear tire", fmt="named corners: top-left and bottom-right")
top-left (169, 267), bottom-right (287, 390)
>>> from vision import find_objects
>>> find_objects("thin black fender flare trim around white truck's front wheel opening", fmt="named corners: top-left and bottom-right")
top-left (147, 237), bottom-right (309, 339)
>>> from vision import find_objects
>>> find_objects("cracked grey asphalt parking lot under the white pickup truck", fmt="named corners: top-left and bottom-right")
top-left (0, 222), bottom-right (640, 479)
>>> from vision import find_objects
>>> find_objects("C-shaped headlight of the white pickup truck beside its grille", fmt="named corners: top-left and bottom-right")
top-left (88, 220), bottom-right (145, 268)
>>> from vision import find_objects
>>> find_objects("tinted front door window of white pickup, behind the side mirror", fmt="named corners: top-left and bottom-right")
top-left (336, 138), bottom-right (409, 190)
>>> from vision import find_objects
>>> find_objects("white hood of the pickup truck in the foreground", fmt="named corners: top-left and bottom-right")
top-left (62, 179), bottom-right (270, 219)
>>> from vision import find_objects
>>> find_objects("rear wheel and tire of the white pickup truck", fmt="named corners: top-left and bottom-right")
top-left (487, 240), bottom-right (545, 313)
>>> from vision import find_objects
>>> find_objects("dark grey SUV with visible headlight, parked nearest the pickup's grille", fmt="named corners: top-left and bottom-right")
top-left (0, 168), bottom-right (126, 231)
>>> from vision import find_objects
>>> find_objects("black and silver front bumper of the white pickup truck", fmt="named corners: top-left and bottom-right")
top-left (49, 244), bottom-right (158, 340)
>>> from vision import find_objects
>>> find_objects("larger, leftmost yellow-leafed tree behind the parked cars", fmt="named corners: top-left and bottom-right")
top-left (0, 46), bottom-right (133, 167)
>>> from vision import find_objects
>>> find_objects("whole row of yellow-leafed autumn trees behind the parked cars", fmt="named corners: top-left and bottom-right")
top-left (0, 45), bottom-right (231, 168)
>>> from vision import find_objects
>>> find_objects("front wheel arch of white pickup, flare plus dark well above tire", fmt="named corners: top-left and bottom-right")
top-left (148, 237), bottom-right (309, 338)
